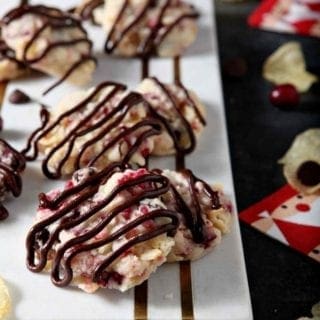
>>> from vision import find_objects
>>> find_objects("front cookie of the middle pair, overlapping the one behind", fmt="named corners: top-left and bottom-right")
top-left (23, 82), bottom-right (161, 178)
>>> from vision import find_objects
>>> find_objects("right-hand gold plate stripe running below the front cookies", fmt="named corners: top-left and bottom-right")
top-left (180, 261), bottom-right (194, 320)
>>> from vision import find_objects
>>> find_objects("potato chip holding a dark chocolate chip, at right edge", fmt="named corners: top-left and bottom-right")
top-left (279, 128), bottom-right (320, 194)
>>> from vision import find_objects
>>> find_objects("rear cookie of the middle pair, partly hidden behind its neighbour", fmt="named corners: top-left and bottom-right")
top-left (136, 77), bottom-right (206, 155)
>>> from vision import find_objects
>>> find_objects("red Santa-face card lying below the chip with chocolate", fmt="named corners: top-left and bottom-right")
top-left (240, 185), bottom-right (320, 262)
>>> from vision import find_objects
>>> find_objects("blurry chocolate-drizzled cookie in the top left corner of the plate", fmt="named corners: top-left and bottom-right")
top-left (2, 4), bottom-right (95, 90)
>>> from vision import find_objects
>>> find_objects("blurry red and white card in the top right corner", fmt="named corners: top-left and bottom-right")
top-left (248, 0), bottom-right (320, 37)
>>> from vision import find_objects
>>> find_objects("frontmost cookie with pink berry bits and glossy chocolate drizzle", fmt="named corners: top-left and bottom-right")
top-left (27, 164), bottom-right (178, 292)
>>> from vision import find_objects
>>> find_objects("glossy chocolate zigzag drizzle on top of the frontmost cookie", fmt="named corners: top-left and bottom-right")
top-left (26, 164), bottom-right (179, 286)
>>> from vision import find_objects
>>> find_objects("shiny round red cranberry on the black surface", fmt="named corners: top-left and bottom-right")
top-left (269, 84), bottom-right (300, 108)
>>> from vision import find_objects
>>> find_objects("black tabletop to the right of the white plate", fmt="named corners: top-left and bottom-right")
top-left (217, 1), bottom-right (320, 320)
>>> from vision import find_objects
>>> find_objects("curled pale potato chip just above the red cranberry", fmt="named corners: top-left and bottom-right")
top-left (263, 41), bottom-right (318, 92)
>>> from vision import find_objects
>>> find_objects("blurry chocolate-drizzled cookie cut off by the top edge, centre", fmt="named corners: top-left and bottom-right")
top-left (103, 0), bottom-right (198, 57)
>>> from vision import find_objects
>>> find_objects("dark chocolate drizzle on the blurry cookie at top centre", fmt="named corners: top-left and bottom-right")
top-left (105, 0), bottom-right (199, 57)
